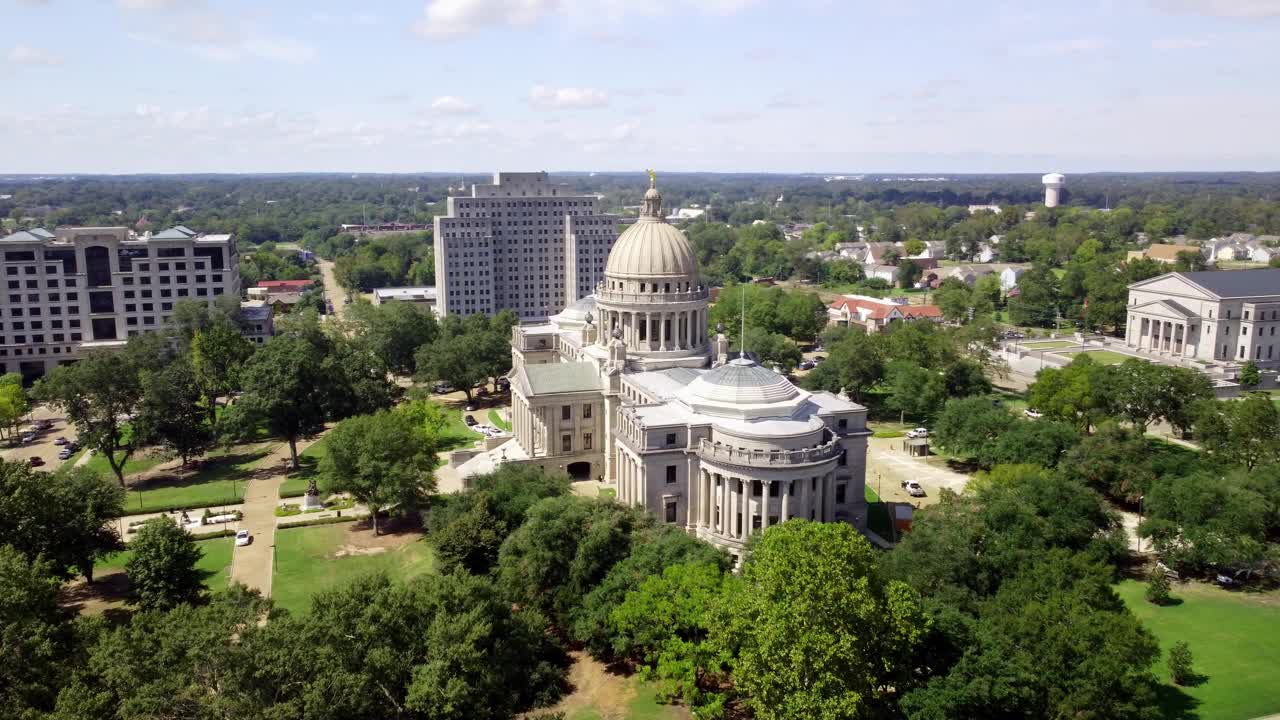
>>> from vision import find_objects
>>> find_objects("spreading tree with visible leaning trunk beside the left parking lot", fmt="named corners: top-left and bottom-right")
top-left (33, 348), bottom-right (146, 487)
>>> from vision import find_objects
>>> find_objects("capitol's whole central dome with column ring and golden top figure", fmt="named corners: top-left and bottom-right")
top-left (595, 170), bottom-right (708, 370)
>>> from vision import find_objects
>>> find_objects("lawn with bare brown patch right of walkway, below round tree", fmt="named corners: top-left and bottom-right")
top-left (271, 523), bottom-right (435, 614)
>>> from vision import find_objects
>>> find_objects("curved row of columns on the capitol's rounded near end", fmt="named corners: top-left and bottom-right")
top-left (690, 469), bottom-right (836, 542)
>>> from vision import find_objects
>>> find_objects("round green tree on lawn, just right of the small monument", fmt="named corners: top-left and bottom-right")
top-left (323, 411), bottom-right (438, 534)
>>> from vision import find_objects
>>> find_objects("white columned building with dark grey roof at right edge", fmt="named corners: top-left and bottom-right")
top-left (1124, 269), bottom-right (1280, 368)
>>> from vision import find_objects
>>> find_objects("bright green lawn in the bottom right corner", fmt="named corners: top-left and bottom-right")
top-left (1116, 580), bottom-right (1280, 720)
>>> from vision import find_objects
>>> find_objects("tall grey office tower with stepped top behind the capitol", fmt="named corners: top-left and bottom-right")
top-left (435, 173), bottom-right (618, 322)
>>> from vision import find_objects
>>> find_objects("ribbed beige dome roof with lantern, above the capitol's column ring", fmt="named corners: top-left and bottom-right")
top-left (604, 175), bottom-right (698, 281)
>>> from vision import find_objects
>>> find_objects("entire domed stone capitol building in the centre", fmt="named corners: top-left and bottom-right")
top-left (458, 175), bottom-right (869, 557)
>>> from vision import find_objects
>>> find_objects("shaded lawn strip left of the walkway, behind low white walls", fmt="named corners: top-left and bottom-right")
top-left (122, 446), bottom-right (271, 512)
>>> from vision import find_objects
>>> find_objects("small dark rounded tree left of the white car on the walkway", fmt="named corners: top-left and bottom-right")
top-left (124, 518), bottom-right (205, 610)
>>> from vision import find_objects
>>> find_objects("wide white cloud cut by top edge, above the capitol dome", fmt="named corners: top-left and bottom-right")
top-left (413, 0), bottom-right (756, 40)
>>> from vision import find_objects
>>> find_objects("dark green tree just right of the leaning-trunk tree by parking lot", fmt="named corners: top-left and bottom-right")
top-left (137, 357), bottom-right (214, 465)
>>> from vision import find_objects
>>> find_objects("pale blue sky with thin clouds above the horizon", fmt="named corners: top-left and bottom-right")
top-left (0, 0), bottom-right (1280, 173)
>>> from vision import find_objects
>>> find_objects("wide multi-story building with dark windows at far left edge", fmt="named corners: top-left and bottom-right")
top-left (0, 225), bottom-right (239, 380)
